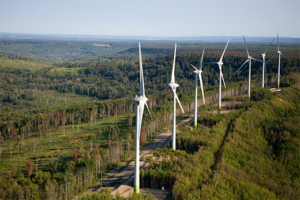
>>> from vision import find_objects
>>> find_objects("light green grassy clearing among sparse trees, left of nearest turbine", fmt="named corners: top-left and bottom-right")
top-left (0, 114), bottom-right (134, 177)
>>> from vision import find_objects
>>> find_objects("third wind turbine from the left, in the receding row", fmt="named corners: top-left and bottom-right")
top-left (191, 48), bottom-right (205, 128)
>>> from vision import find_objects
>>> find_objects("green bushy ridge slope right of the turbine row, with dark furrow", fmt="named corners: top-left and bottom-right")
top-left (141, 74), bottom-right (300, 199)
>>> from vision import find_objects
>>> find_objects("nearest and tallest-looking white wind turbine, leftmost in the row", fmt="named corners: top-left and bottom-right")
top-left (132, 43), bottom-right (152, 194)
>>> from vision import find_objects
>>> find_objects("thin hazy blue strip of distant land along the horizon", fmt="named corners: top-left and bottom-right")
top-left (0, 32), bottom-right (300, 44)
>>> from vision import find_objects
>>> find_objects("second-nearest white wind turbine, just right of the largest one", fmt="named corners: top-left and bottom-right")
top-left (164, 43), bottom-right (184, 150)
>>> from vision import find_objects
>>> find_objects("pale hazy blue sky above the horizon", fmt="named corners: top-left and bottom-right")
top-left (0, 0), bottom-right (300, 37)
